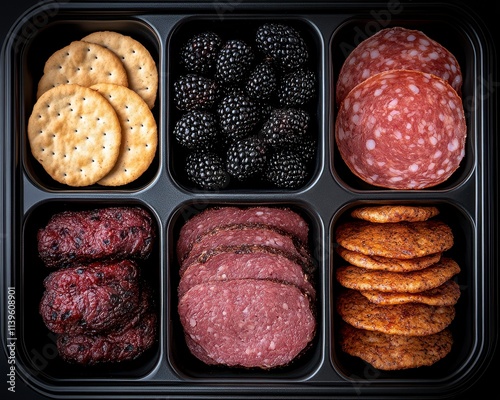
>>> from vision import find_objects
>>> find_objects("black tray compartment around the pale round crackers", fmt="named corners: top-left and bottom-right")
top-left (18, 18), bottom-right (162, 192)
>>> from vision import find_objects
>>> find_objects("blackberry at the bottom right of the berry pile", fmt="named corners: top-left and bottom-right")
top-left (263, 150), bottom-right (308, 189)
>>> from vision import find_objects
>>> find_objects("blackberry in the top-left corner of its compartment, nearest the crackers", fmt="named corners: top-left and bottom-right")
top-left (180, 31), bottom-right (222, 75)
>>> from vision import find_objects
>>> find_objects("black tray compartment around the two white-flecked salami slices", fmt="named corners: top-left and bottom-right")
top-left (330, 18), bottom-right (479, 192)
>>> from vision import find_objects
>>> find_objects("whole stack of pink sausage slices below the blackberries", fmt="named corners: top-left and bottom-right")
top-left (177, 207), bottom-right (316, 369)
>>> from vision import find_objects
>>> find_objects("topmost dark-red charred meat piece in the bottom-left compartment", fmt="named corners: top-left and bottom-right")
top-left (38, 207), bottom-right (155, 267)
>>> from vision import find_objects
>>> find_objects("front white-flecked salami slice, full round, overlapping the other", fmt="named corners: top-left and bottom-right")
top-left (335, 70), bottom-right (467, 189)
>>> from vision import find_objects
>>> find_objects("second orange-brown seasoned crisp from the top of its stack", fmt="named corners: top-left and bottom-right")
top-left (336, 220), bottom-right (453, 259)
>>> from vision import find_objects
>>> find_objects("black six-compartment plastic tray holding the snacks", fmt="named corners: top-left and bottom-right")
top-left (0, 2), bottom-right (498, 398)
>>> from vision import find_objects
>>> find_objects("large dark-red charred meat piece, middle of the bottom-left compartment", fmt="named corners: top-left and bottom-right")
top-left (39, 260), bottom-right (140, 334)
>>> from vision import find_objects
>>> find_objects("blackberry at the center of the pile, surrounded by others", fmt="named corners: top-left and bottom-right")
top-left (217, 89), bottom-right (259, 144)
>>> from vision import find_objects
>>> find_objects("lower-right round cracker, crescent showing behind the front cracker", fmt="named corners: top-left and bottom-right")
top-left (91, 83), bottom-right (158, 186)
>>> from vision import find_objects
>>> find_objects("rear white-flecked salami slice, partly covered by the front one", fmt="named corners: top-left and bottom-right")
top-left (336, 27), bottom-right (462, 105)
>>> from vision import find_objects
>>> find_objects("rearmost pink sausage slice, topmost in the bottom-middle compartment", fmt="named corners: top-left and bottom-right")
top-left (177, 206), bottom-right (309, 262)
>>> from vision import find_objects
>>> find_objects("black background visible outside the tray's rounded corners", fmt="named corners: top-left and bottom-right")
top-left (0, 0), bottom-right (500, 400)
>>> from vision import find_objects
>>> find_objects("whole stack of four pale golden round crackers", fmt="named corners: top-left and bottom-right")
top-left (27, 31), bottom-right (158, 186)
